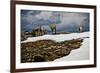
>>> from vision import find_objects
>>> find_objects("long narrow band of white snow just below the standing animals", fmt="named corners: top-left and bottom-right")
top-left (21, 32), bottom-right (89, 43)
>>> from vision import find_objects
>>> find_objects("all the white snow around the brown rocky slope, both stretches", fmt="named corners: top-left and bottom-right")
top-left (22, 32), bottom-right (90, 62)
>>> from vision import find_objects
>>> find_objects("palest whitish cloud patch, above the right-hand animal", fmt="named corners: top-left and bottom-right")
top-left (61, 13), bottom-right (86, 25)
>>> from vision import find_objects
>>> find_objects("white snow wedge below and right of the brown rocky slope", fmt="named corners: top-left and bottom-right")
top-left (54, 38), bottom-right (89, 62)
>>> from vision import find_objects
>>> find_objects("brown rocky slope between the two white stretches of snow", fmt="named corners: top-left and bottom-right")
top-left (21, 39), bottom-right (83, 63)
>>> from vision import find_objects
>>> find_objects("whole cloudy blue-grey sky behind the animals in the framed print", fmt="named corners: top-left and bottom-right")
top-left (21, 10), bottom-right (90, 32)
